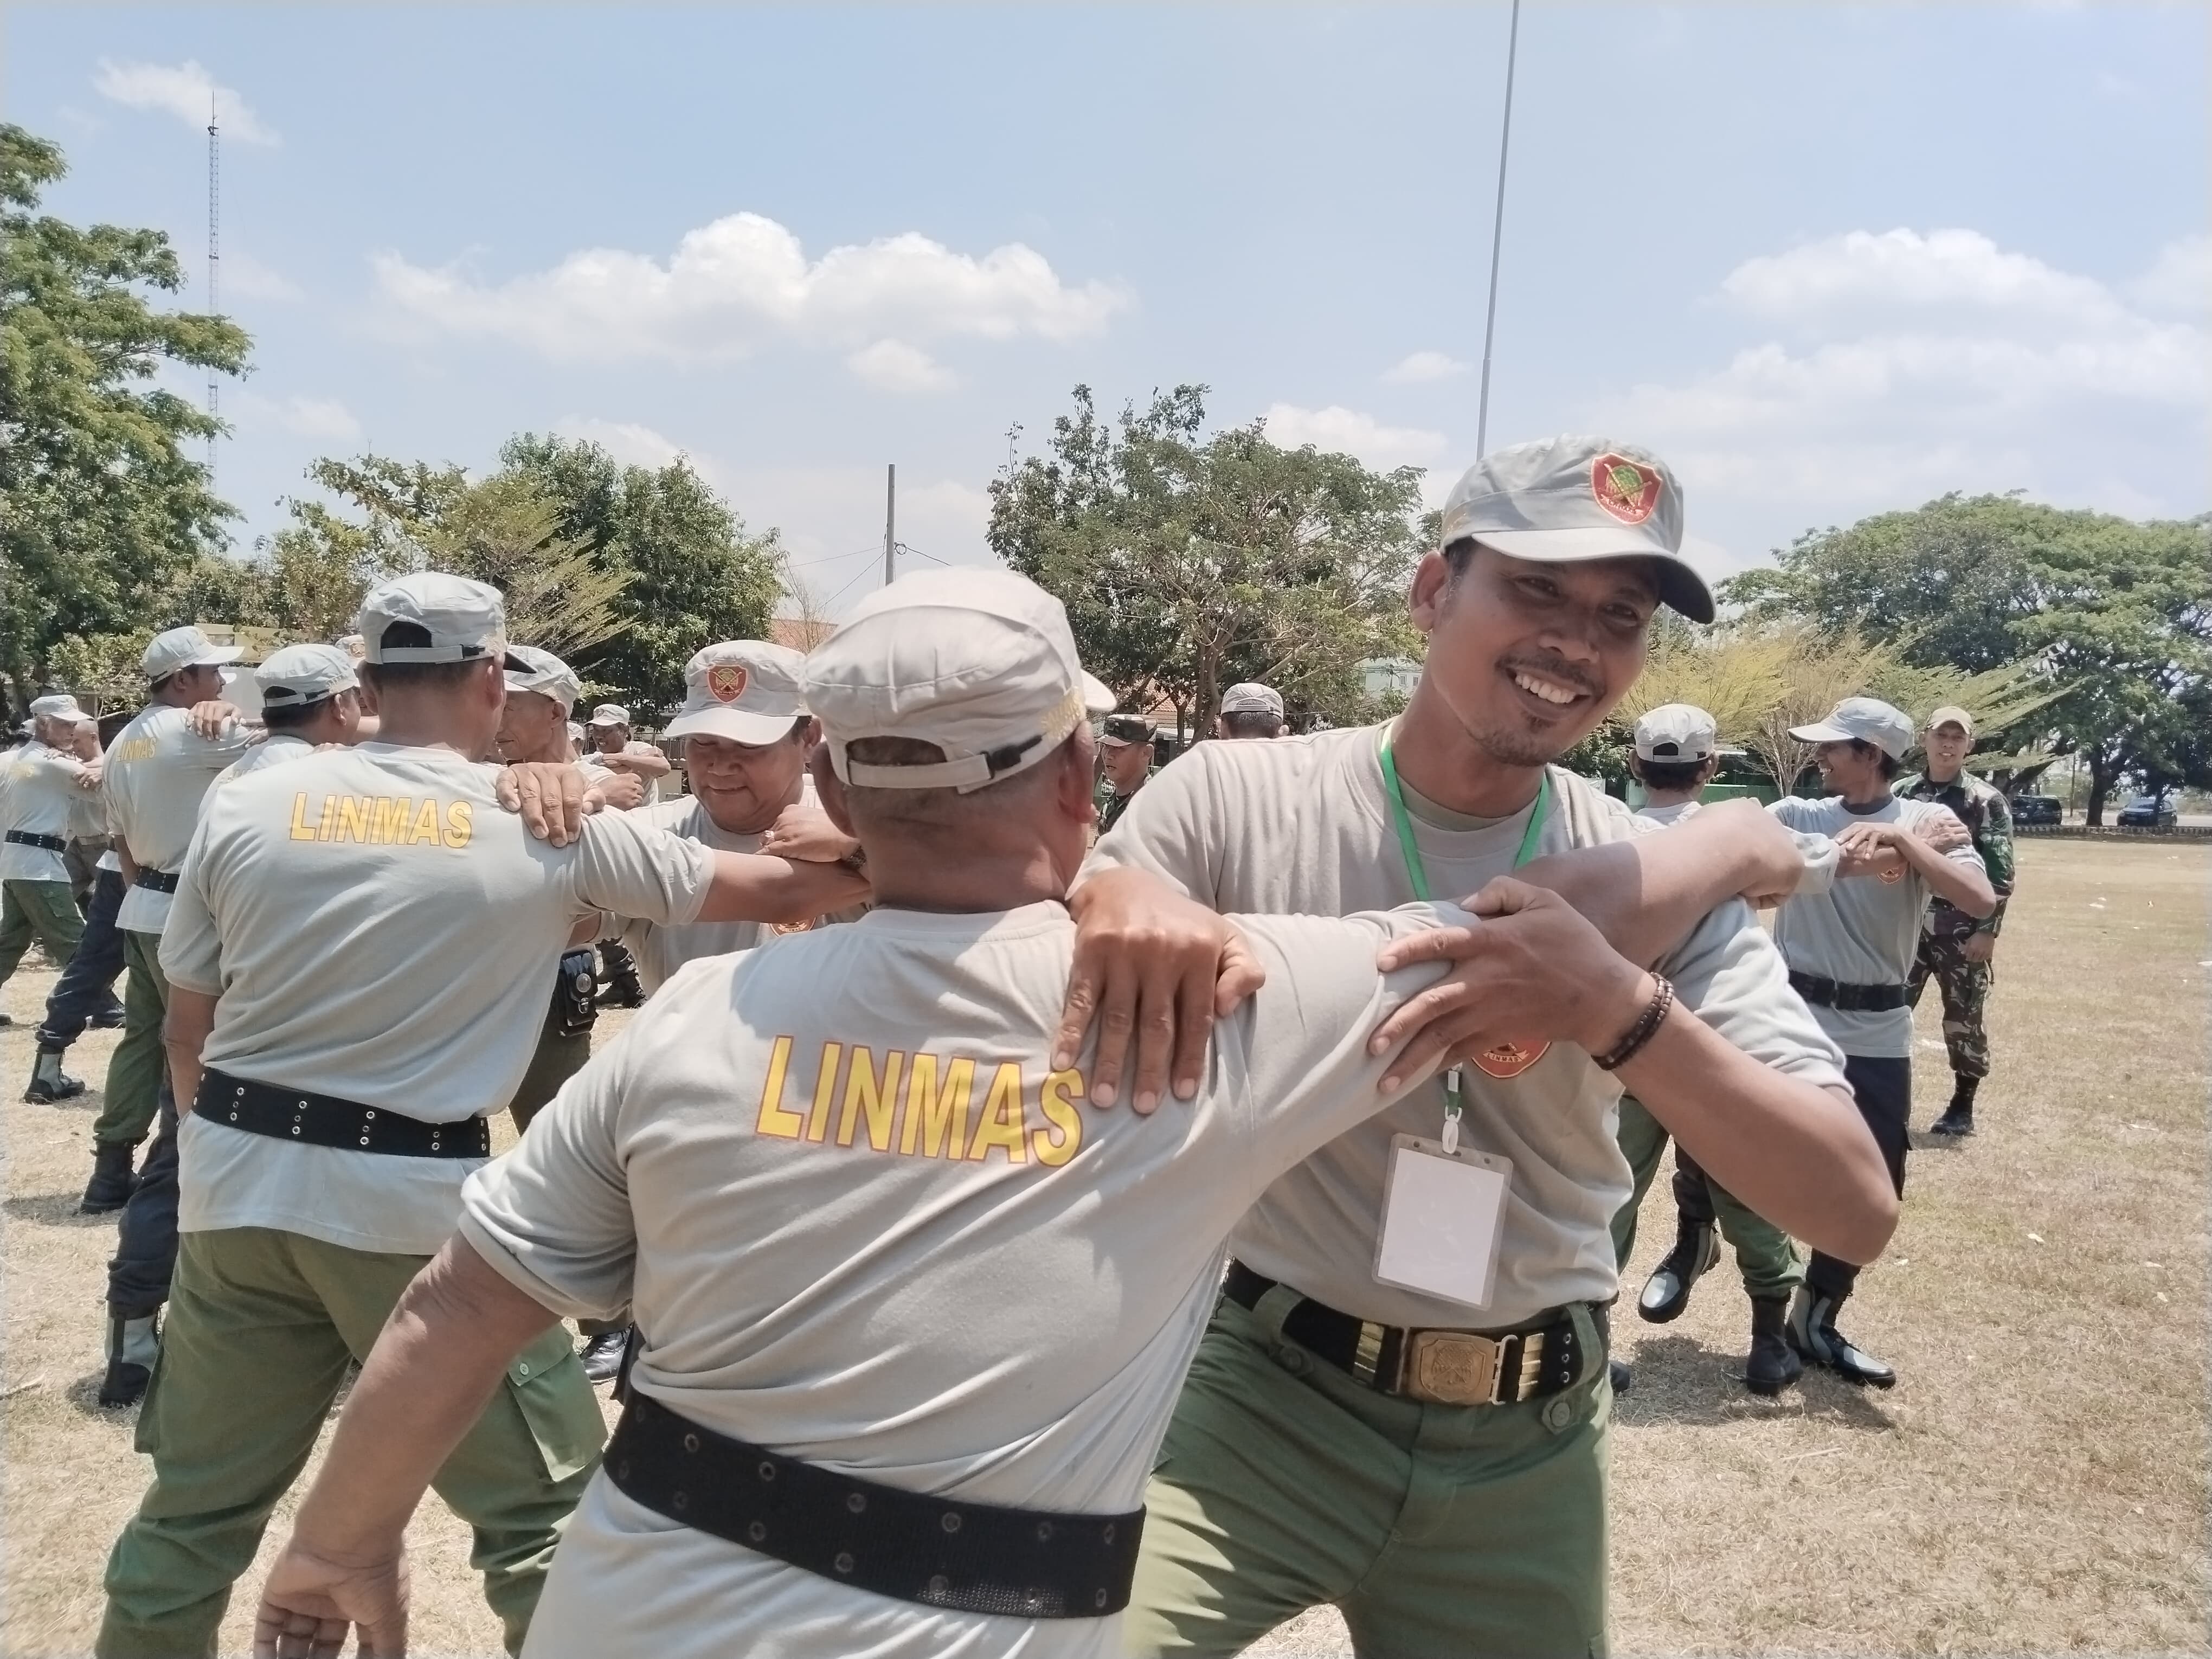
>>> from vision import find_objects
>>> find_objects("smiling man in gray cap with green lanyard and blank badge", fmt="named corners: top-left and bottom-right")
top-left (1075, 438), bottom-right (1896, 1655)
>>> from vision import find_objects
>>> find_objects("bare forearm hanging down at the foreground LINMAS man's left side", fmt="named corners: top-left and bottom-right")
top-left (292, 1239), bottom-right (553, 1561)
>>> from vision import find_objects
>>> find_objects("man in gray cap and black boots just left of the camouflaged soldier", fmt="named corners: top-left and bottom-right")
top-left (1770, 697), bottom-right (1997, 1389)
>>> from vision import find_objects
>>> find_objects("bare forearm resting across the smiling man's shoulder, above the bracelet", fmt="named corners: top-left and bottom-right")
top-left (1513, 803), bottom-right (1803, 967)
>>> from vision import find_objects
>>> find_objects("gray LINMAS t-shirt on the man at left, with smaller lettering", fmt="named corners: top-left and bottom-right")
top-left (162, 743), bottom-right (715, 1254)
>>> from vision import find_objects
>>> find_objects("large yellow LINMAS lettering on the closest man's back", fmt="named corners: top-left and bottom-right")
top-left (754, 1038), bottom-right (1084, 1168)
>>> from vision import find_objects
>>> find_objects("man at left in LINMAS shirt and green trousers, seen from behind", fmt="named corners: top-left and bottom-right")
top-left (95, 573), bottom-right (858, 1659)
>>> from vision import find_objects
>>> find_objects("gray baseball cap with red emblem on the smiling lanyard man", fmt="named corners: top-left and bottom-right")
top-left (1440, 434), bottom-right (1712, 621)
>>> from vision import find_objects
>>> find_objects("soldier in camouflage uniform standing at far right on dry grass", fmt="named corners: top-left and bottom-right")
top-left (1898, 706), bottom-right (2013, 1135)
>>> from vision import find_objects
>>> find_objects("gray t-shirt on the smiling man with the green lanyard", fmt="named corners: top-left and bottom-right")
top-left (1093, 725), bottom-right (1843, 1329)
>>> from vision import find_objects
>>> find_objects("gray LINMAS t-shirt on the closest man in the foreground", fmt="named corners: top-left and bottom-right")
top-left (460, 905), bottom-right (1460, 1659)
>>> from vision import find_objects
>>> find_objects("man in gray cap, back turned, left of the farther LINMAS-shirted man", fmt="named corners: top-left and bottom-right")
top-left (84, 628), bottom-right (261, 1214)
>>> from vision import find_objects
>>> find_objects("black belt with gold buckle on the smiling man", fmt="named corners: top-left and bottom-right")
top-left (1221, 1261), bottom-right (1610, 1405)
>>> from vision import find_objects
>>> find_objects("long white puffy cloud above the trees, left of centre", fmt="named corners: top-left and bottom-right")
top-left (374, 213), bottom-right (1128, 363)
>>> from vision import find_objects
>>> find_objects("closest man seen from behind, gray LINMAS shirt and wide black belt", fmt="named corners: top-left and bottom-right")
top-left (242, 571), bottom-right (1856, 1659)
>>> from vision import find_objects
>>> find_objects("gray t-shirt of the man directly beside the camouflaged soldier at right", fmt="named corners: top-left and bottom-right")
top-left (1767, 796), bottom-right (1982, 1057)
